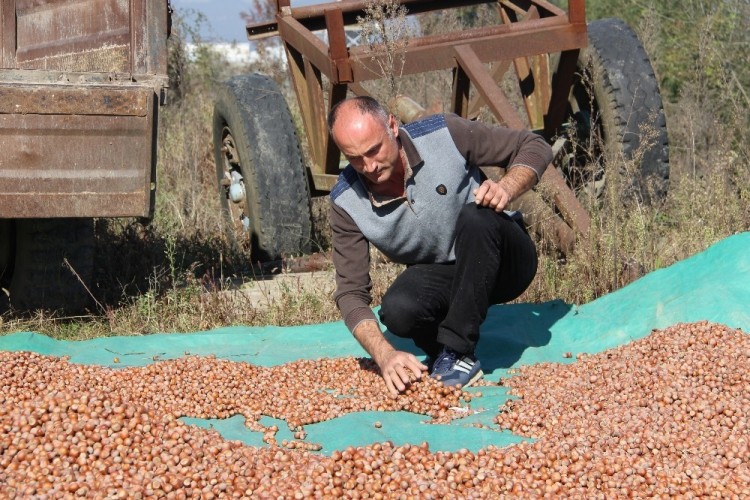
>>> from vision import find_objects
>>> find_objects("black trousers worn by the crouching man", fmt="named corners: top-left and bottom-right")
top-left (380, 203), bottom-right (537, 356)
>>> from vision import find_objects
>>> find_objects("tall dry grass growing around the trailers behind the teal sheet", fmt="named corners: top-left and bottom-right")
top-left (0, 3), bottom-right (750, 339)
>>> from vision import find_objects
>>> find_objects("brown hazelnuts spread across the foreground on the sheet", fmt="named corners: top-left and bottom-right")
top-left (0, 322), bottom-right (750, 498)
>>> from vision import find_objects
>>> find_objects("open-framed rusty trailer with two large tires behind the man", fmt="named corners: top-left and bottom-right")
top-left (213, 0), bottom-right (669, 260)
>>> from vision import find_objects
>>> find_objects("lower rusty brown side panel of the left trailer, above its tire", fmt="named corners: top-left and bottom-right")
top-left (0, 109), bottom-right (156, 218)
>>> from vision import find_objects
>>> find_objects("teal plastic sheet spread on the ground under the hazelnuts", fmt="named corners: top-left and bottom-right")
top-left (0, 233), bottom-right (750, 453)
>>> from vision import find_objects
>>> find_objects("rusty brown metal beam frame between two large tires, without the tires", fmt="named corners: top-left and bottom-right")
top-left (247, 0), bottom-right (590, 246)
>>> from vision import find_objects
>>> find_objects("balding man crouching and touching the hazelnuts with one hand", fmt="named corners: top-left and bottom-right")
top-left (328, 97), bottom-right (552, 396)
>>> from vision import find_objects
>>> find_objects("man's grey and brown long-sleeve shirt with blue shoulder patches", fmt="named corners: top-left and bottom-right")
top-left (330, 114), bottom-right (552, 331)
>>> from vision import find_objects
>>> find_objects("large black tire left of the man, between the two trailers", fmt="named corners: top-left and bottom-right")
top-left (213, 74), bottom-right (312, 262)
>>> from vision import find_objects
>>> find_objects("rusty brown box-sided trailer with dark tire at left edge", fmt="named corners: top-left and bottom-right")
top-left (0, 0), bottom-right (170, 311)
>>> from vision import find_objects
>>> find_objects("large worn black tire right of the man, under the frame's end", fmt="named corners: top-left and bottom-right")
top-left (563, 19), bottom-right (669, 203)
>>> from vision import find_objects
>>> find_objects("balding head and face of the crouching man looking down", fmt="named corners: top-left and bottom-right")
top-left (332, 106), bottom-right (403, 184)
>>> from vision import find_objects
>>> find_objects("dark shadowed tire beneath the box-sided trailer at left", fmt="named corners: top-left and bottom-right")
top-left (0, 219), bottom-right (94, 313)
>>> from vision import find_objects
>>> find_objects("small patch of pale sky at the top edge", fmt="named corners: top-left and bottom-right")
top-left (171, 0), bottom-right (328, 42)
